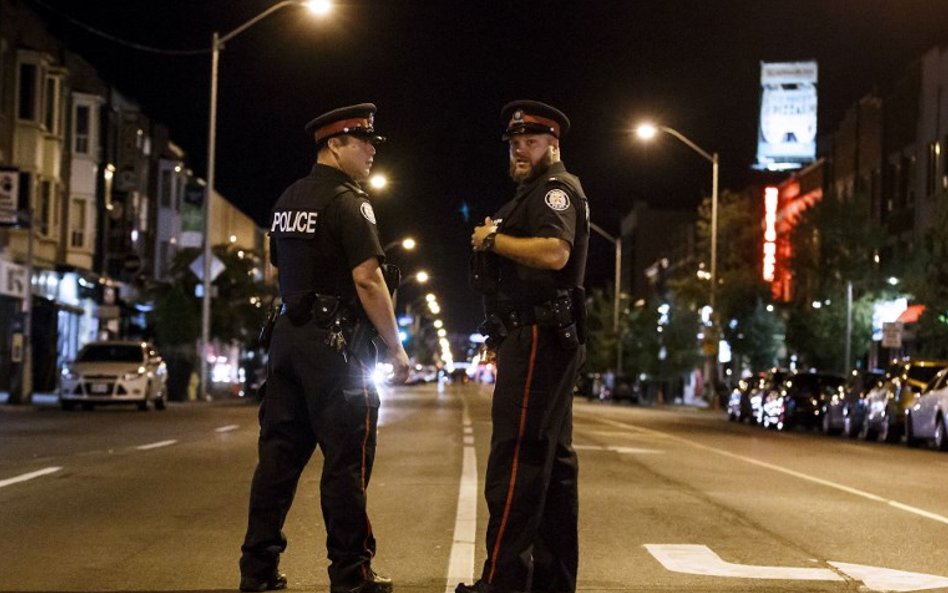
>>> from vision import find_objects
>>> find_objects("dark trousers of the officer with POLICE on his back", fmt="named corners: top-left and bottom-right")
top-left (240, 317), bottom-right (379, 586)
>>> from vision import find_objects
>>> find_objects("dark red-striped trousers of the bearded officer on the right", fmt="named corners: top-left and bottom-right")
top-left (481, 325), bottom-right (585, 593)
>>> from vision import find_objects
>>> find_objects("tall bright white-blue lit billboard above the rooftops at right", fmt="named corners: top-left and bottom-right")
top-left (755, 62), bottom-right (818, 171)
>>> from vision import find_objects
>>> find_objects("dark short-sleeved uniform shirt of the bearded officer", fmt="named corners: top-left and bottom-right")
top-left (494, 162), bottom-right (589, 306)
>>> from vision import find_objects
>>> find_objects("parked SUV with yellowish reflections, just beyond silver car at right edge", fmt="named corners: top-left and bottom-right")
top-left (859, 359), bottom-right (948, 443)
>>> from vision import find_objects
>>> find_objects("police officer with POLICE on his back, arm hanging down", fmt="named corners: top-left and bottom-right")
top-left (240, 103), bottom-right (408, 593)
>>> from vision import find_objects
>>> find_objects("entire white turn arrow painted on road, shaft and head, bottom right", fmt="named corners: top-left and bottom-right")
top-left (645, 544), bottom-right (948, 591)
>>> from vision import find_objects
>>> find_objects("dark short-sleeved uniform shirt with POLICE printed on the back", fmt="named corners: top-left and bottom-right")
top-left (269, 164), bottom-right (385, 307)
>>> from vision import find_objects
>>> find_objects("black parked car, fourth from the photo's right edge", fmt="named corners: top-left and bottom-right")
top-left (762, 372), bottom-right (846, 430)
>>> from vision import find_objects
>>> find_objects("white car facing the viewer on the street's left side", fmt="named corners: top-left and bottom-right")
top-left (59, 340), bottom-right (168, 410)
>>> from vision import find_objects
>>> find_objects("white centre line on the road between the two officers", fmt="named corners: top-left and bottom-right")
top-left (444, 399), bottom-right (477, 593)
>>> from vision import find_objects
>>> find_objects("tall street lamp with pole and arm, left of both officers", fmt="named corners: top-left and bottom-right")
top-left (200, 0), bottom-right (332, 397)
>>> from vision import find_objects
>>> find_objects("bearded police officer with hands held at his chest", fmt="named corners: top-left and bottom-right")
top-left (456, 101), bottom-right (589, 593)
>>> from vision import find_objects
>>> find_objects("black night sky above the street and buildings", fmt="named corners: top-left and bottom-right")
top-left (30, 0), bottom-right (948, 332)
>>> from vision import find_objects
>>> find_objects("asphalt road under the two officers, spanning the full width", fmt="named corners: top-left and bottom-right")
top-left (0, 385), bottom-right (948, 593)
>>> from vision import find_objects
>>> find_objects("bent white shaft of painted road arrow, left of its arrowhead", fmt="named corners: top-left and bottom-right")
top-left (645, 544), bottom-right (844, 581)
